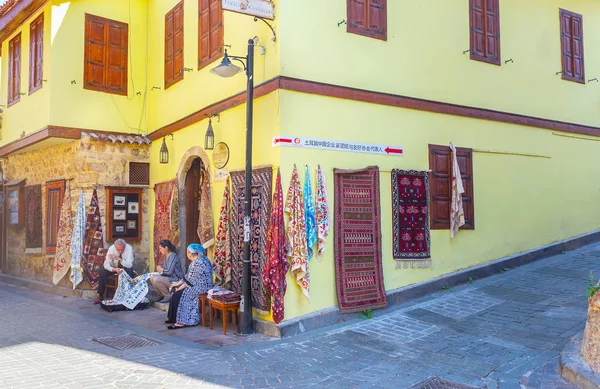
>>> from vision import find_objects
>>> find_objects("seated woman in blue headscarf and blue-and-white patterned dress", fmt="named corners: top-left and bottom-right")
top-left (165, 243), bottom-right (213, 330)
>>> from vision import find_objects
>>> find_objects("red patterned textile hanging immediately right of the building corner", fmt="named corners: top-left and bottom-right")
top-left (264, 171), bottom-right (289, 323)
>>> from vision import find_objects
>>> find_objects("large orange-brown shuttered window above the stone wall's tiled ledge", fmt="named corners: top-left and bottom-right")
top-left (83, 14), bottom-right (128, 96)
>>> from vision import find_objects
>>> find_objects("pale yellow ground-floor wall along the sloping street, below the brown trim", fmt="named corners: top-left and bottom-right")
top-left (278, 91), bottom-right (600, 319)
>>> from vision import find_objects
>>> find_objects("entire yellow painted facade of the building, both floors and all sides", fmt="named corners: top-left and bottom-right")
top-left (0, 0), bottom-right (600, 328)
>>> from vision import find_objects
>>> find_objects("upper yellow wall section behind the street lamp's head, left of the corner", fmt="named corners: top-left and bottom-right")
top-left (148, 0), bottom-right (280, 131)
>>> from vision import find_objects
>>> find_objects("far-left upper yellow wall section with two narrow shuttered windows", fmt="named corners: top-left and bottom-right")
top-left (0, 6), bottom-right (51, 144)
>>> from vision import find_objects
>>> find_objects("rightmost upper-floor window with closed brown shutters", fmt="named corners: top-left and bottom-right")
top-left (560, 9), bottom-right (585, 84)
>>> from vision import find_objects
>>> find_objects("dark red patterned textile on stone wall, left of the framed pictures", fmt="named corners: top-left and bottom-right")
top-left (81, 189), bottom-right (106, 288)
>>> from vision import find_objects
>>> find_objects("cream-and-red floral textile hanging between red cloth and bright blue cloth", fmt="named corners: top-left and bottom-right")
top-left (285, 165), bottom-right (310, 300)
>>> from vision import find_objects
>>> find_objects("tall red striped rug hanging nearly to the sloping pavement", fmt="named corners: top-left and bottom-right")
top-left (334, 167), bottom-right (387, 313)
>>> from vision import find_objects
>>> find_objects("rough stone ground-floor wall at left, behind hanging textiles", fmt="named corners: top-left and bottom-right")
top-left (2, 136), bottom-right (150, 289)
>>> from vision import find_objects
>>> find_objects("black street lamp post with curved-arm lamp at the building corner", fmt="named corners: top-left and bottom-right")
top-left (210, 39), bottom-right (255, 335)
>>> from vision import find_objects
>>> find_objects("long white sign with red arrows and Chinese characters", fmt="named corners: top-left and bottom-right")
top-left (272, 135), bottom-right (404, 157)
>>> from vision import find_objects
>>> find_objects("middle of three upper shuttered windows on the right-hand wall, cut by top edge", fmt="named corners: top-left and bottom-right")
top-left (469, 0), bottom-right (500, 65)
